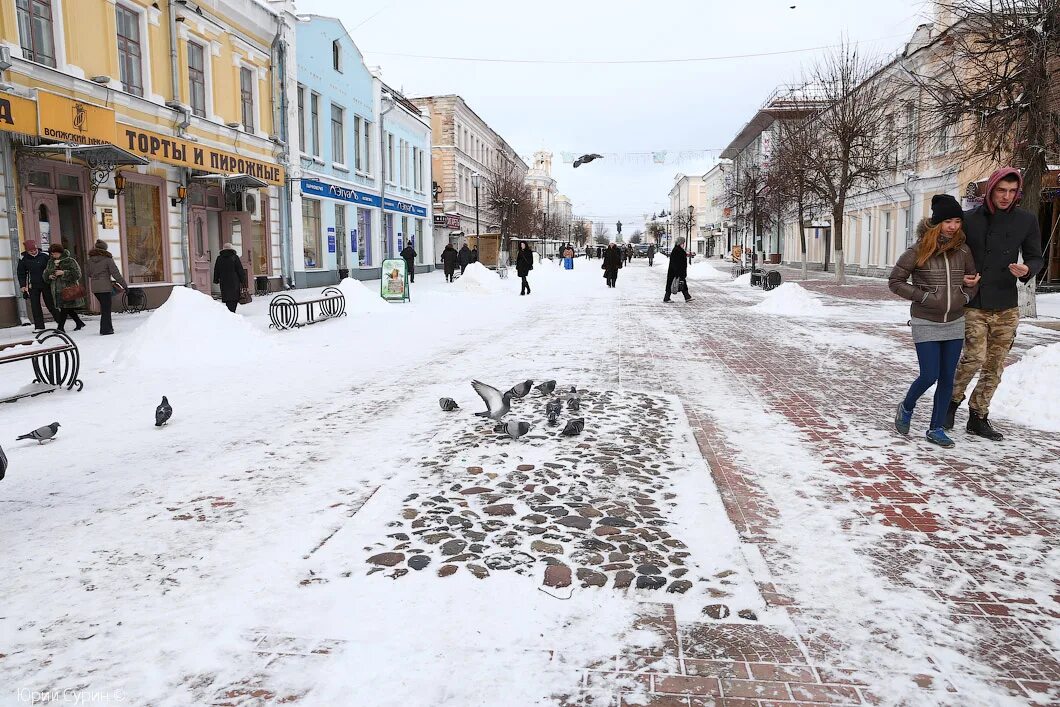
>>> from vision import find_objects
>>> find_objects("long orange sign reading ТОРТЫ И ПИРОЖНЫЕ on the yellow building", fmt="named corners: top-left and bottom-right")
top-left (117, 123), bottom-right (284, 187)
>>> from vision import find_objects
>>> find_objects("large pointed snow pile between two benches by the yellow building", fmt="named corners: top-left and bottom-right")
top-left (116, 287), bottom-right (271, 369)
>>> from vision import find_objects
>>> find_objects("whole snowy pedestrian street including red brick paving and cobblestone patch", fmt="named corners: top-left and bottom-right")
top-left (0, 259), bottom-right (1060, 707)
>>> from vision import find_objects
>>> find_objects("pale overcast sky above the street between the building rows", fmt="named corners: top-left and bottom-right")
top-left (298, 0), bottom-right (931, 233)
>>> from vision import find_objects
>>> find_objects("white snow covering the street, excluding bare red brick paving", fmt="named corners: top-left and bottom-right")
top-left (0, 260), bottom-right (1060, 706)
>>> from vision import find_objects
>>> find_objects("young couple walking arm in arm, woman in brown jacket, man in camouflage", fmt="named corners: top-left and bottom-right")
top-left (888, 167), bottom-right (1044, 447)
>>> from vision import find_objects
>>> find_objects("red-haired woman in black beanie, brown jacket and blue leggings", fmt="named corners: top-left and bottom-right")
top-left (887, 194), bottom-right (979, 447)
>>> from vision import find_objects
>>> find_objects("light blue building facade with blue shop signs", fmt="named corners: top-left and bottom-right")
top-left (288, 15), bottom-right (434, 287)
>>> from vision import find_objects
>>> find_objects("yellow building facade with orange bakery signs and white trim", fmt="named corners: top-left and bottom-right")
top-left (0, 0), bottom-right (294, 325)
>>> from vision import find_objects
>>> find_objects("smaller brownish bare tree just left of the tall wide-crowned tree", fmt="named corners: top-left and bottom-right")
top-left (765, 117), bottom-right (831, 280)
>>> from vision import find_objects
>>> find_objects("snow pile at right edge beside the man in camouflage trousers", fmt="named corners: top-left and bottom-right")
top-left (991, 343), bottom-right (1060, 432)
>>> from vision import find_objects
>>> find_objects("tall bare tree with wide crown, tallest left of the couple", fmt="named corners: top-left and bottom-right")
top-left (807, 42), bottom-right (899, 284)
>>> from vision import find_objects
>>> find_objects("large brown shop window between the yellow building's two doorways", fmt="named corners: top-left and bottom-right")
top-left (123, 180), bottom-right (165, 282)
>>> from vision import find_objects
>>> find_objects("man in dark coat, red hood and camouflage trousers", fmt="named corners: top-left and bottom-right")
top-left (943, 167), bottom-right (1045, 442)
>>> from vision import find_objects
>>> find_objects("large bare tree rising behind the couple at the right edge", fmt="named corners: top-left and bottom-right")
top-left (908, 0), bottom-right (1060, 309)
